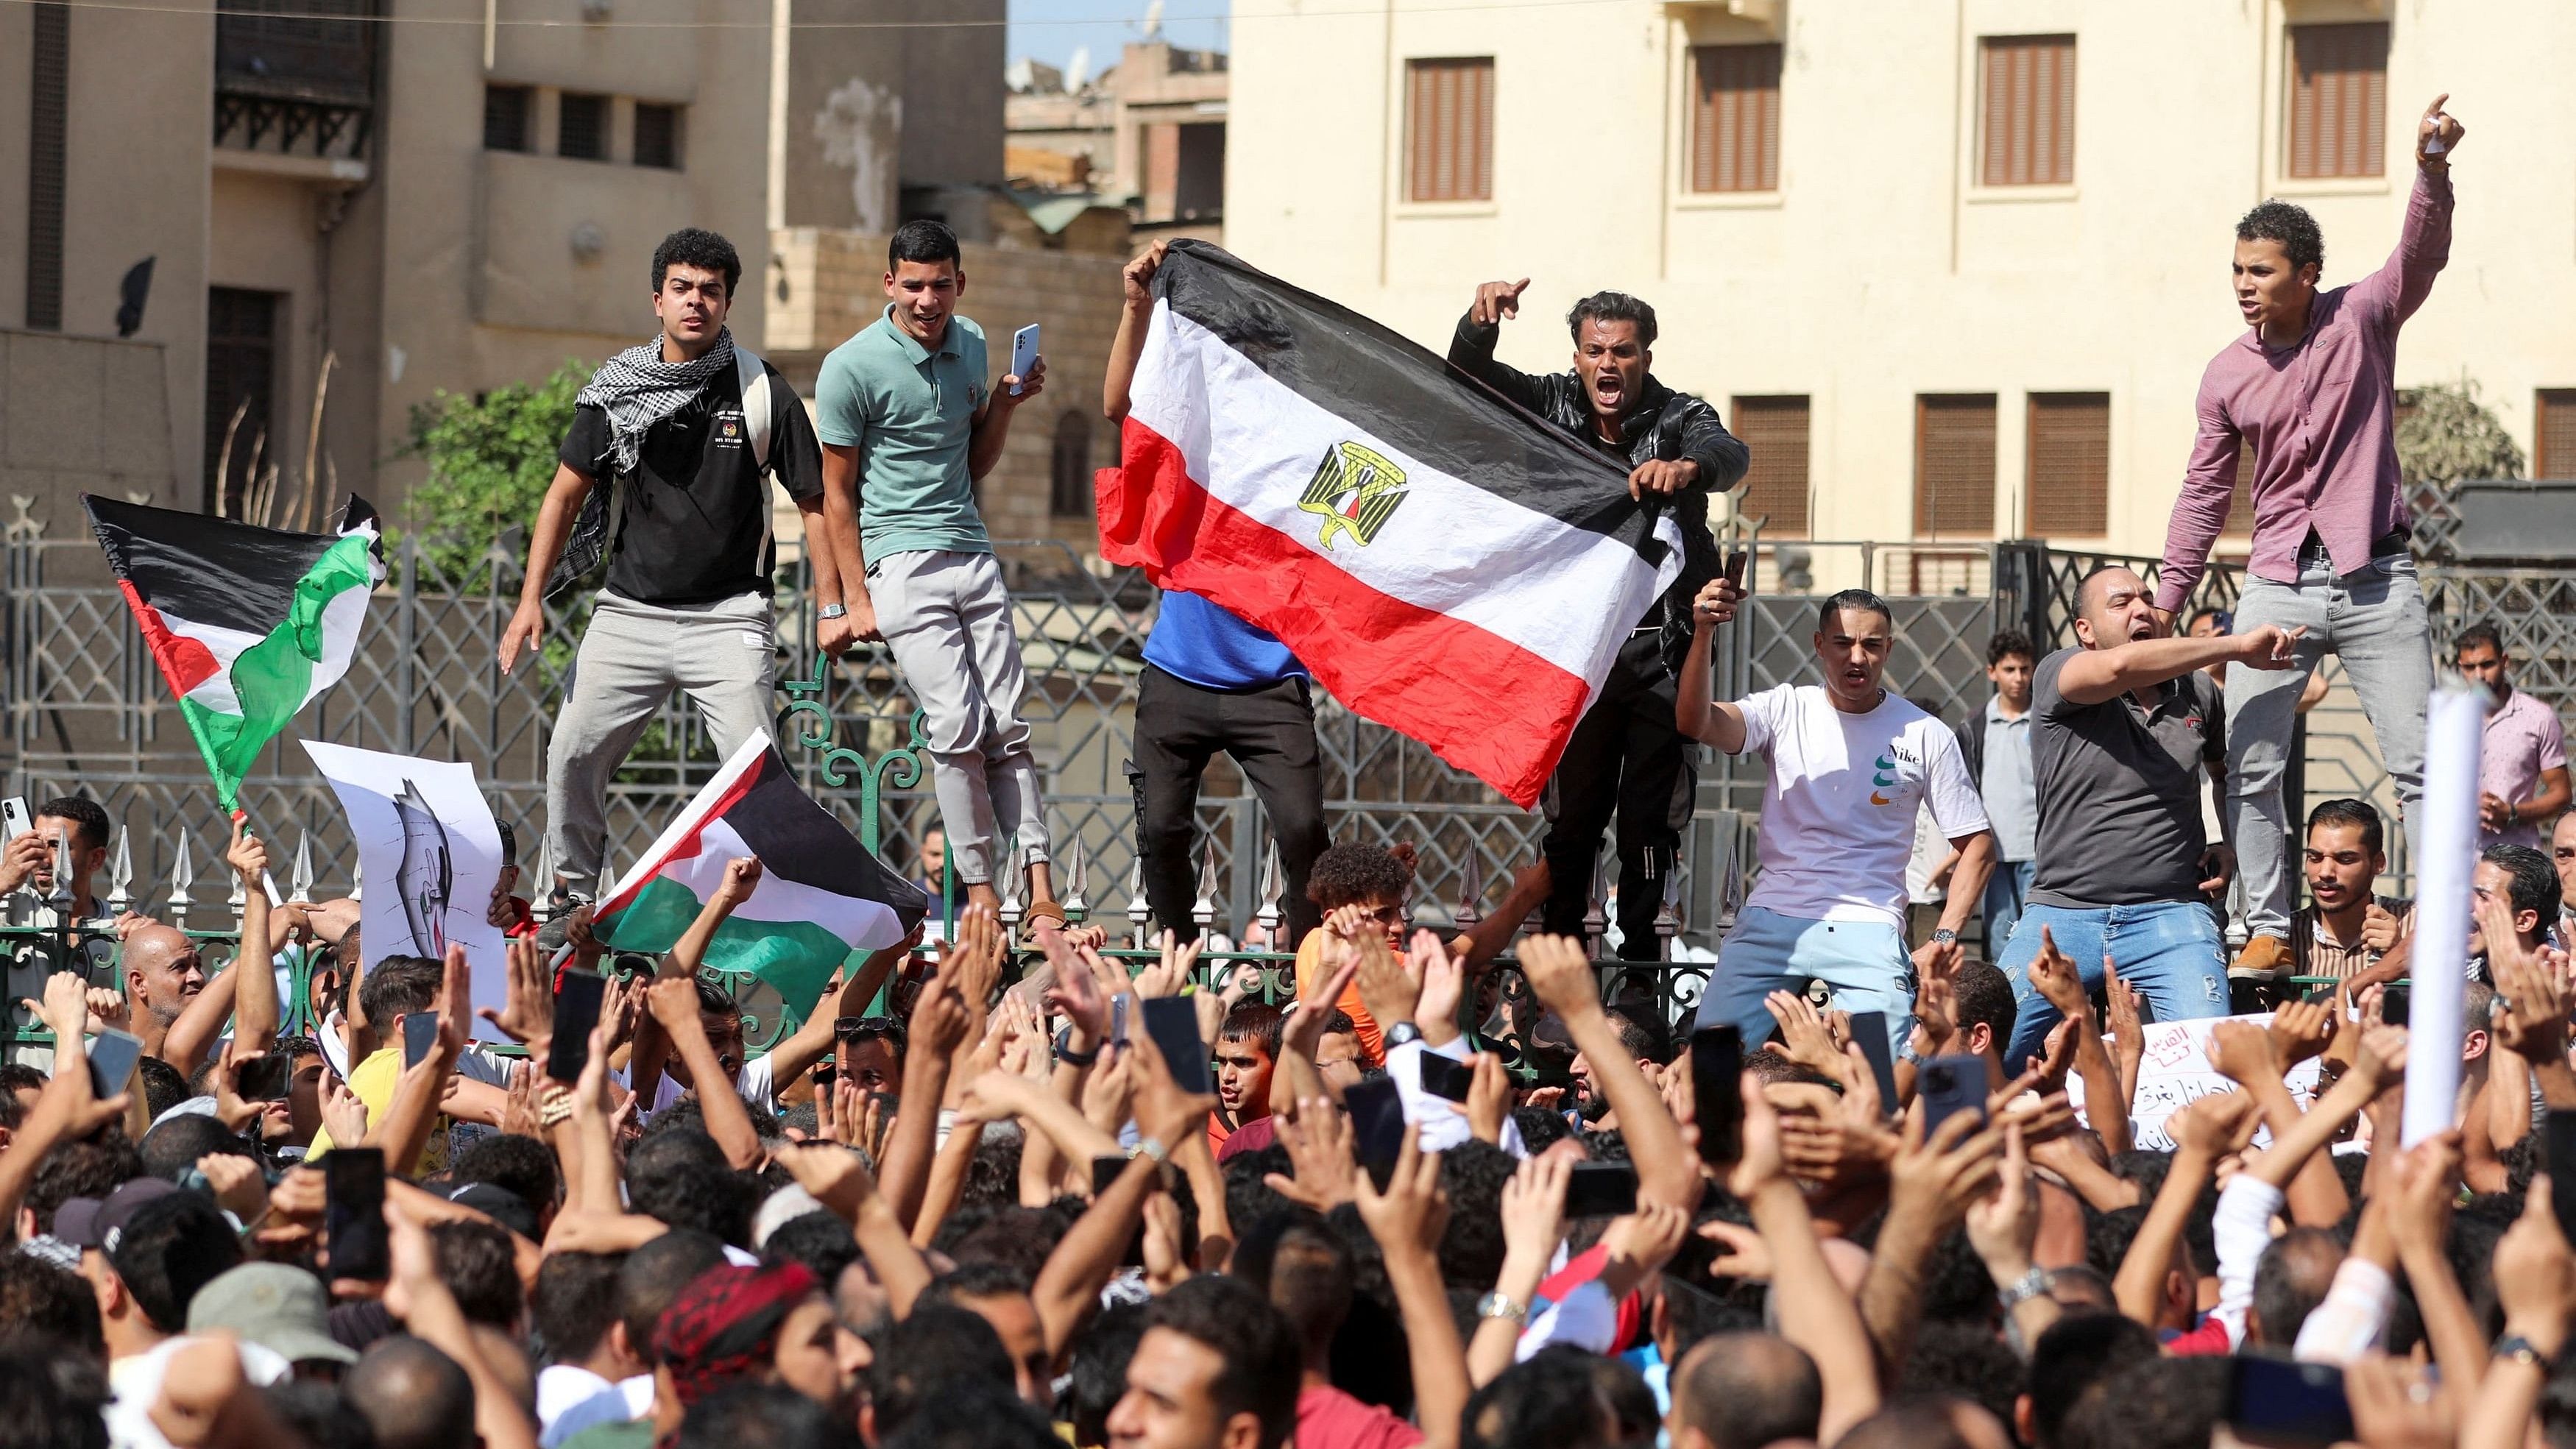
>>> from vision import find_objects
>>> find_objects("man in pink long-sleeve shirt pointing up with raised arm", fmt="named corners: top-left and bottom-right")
top-left (2156, 95), bottom-right (2466, 975)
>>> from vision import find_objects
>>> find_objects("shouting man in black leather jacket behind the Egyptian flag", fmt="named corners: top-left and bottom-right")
top-left (1448, 278), bottom-right (1749, 960)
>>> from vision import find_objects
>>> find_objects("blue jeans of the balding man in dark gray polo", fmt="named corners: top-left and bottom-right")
top-left (1994, 901), bottom-right (2229, 1071)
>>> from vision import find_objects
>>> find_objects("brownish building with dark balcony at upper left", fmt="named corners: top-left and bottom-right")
top-left (0, 0), bottom-right (1002, 530)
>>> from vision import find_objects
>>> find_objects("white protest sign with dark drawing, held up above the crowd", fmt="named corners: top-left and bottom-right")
top-left (302, 739), bottom-right (510, 1042)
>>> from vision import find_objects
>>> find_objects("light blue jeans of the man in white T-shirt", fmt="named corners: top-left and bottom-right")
top-left (1693, 906), bottom-right (1914, 1055)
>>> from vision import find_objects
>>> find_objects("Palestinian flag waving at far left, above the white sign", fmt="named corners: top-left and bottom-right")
top-left (80, 494), bottom-right (384, 811)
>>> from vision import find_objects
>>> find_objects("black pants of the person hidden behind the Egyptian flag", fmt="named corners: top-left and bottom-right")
top-left (1128, 664), bottom-right (1329, 942)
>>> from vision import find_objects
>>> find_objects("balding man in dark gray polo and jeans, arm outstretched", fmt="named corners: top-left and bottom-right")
top-left (1994, 564), bottom-right (2298, 1071)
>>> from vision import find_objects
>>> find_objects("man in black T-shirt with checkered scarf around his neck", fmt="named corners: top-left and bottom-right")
top-left (500, 227), bottom-right (840, 906)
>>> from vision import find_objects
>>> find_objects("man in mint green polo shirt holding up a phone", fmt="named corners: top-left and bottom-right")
top-left (814, 222), bottom-right (1064, 921)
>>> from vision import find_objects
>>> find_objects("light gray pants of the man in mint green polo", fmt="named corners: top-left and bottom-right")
top-left (868, 548), bottom-right (1049, 885)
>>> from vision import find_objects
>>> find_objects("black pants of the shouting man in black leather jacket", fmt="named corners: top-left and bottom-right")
top-left (1540, 631), bottom-right (1698, 960)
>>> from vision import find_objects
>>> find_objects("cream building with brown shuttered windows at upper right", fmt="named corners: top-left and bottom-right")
top-left (1226, 0), bottom-right (2576, 563)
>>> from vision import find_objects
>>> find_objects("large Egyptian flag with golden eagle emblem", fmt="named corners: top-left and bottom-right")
top-left (1097, 242), bottom-right (1682, 808)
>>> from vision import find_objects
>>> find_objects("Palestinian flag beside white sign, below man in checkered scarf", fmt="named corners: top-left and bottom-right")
top-left (592, 734), bottom-right (930, 1009)
